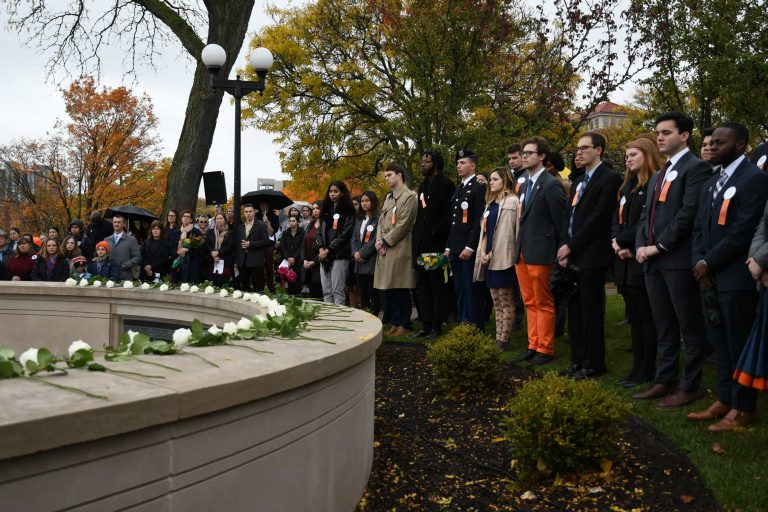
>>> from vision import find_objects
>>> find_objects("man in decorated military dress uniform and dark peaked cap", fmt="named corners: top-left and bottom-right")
top-left (445, 149), bottom-right (486, 331)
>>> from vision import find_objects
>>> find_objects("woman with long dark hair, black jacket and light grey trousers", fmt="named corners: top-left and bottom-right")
top-left (315, 181), bottom-right (355, 305)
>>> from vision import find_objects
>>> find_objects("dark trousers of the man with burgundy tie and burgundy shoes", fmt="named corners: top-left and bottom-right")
top-left (645, 269), bottom-right (709, 392)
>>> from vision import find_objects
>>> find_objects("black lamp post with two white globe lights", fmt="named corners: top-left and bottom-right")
top-left (201, 44), bottom-right (274, 236)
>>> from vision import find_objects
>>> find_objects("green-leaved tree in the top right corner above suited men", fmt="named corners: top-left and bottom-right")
top-left (630, 0), bottom-right (768, 140)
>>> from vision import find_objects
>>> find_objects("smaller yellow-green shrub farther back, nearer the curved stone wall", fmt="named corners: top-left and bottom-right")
top-left (427, 324), bottom-right (501, 393)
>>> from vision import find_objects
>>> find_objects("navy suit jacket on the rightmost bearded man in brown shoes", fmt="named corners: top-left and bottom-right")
top-left (691, 158), bottom-right (768, 292)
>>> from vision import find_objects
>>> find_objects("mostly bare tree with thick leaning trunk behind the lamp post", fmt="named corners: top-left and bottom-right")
top-left (5, 0), bottom-right (254, 216)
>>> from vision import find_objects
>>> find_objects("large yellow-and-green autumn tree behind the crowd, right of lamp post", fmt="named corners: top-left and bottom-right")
top-left (244, 0), bottom-right (642, 196)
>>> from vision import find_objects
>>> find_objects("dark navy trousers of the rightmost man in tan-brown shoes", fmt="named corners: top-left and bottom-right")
top-left (702, 290), bottom-right (759, 412)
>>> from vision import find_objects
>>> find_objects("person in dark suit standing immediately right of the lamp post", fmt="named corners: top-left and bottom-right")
top-left (236, 204), bottom-right (275, 293)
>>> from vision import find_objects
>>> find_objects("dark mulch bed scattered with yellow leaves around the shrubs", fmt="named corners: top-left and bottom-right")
top-left (358, 344), bottom-right (720, 512)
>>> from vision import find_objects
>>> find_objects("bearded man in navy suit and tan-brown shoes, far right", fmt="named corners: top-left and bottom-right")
top-left (688, 123), bottom-right (768, 432)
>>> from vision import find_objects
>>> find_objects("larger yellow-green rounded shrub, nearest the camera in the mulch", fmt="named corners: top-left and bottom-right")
top-left (503, 373), bottom-right (629, 479)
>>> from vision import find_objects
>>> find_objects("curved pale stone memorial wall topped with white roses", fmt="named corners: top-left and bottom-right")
top-left (0, 283), bottom-right (381, 511)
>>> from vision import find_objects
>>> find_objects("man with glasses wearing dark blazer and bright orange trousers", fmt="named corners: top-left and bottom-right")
top-left (513, 137), bottom-right (565, 365)
